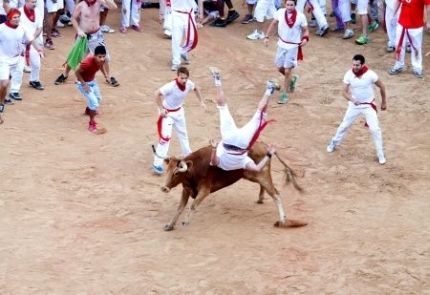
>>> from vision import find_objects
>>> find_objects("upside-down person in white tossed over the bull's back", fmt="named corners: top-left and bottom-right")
top-left (209, 67), bottom-right (279, 171)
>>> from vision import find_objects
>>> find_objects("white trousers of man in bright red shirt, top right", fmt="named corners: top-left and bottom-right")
top-left (394, 23), bottom-right (423, 71)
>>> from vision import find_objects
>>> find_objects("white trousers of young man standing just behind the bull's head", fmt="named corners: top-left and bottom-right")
top-left (154, 108), bottom-right (191, 166)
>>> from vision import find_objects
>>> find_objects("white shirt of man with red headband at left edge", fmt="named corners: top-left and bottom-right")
top-left (0, 24), bottom-right (33, 60)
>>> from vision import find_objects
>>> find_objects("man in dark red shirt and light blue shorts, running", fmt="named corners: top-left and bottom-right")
top-left (75, 45), bottom-right (106, 134)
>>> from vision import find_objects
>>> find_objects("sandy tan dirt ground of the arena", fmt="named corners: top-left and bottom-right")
top-left (0, 5), bottom-right (430, 294)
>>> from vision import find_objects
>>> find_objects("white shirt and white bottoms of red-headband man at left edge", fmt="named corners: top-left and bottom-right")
top-left (0, 23), bottom-right (33, 80)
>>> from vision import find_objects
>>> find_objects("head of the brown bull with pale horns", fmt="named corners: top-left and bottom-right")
top-left (161, 157), bottom-right (193, 193)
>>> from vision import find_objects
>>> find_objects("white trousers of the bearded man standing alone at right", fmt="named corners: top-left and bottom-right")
top-left (332, 102), bottom-right (384, 158)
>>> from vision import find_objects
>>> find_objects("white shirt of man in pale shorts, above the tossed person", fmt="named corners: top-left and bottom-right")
top-left (274, 8), bottom-right (308, 49)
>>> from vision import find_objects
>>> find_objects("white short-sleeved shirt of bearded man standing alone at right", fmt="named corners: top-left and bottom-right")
top-left (343, 69), bottom-right (378, 103)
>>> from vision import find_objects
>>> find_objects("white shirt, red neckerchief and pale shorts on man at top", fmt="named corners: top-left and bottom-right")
top-left (274, 8), bottom-right (308, 69)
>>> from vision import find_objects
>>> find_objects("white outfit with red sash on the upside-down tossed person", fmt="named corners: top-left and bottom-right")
top-left (216, 105), bottom-right (266, 171)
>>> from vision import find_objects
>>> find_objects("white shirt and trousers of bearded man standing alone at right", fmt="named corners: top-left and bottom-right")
top-left (332, 70), bottom-right (384, 159)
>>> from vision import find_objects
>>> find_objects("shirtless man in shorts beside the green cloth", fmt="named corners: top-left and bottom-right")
top-left (54, 0), bottom-right (119, 87)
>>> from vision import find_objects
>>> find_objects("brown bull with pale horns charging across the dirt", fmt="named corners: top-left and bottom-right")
top-left (161, 142), bottom-right (306, 231)
